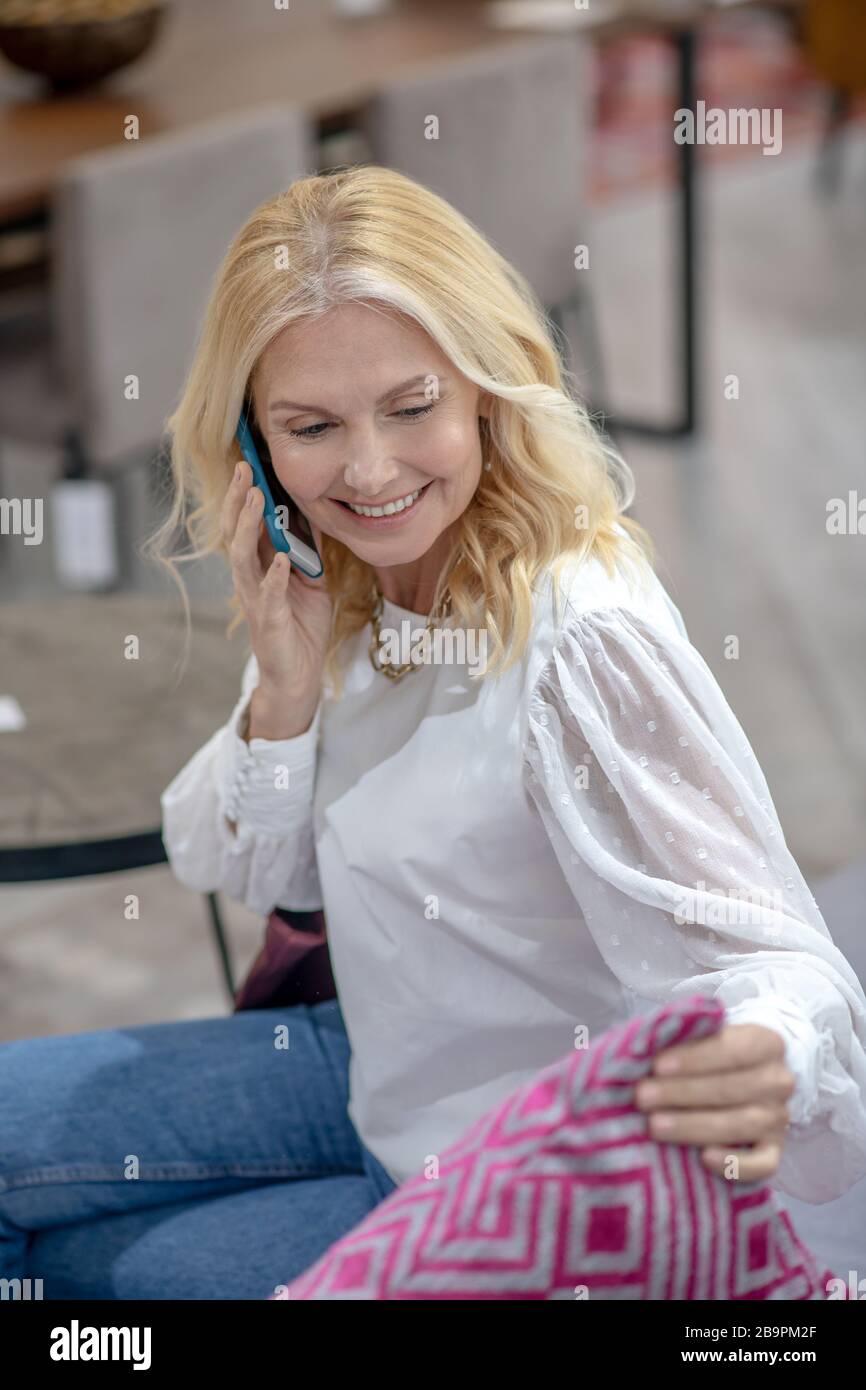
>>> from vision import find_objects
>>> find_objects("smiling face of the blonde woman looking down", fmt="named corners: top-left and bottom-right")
top-left (253, 303), bottom-right (488, 577)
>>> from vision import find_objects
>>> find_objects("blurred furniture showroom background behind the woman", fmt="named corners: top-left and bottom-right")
top-left (0, 0), bottom-right (866, 1038)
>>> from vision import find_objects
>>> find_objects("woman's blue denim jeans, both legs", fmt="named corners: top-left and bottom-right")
top-left (0, 999), bottom-right (396, 1298)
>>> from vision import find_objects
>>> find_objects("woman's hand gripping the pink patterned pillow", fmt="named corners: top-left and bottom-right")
top-left (635, 1023), bottom-right (796, 1183)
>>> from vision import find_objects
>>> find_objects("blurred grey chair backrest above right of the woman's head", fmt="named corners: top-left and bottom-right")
top-left (363, 33), bottom-right (592, 306)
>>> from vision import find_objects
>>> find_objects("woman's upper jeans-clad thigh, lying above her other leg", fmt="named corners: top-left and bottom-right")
top-left (0, 999), bottom-right (393, 1297)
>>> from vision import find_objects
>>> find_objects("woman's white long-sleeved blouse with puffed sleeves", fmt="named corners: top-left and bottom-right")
top-left (163, 542), bottom-right (866, 1202)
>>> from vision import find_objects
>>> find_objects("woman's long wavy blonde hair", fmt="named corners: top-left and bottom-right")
top-left (142, 164), bottom-right (653, 692)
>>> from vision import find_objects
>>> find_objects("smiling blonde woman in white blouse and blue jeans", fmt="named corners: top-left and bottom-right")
top-left (0, 167), bottom-right (866, 1298)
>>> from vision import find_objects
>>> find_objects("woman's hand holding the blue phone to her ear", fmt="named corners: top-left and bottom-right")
top-left (220, 460), bottom-right (332, 737)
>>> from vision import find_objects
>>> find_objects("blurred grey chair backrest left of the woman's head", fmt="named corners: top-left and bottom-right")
top-left (51, 104), bottom-right (314, 471)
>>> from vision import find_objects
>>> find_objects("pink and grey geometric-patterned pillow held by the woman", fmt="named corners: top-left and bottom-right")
top-left (271, 995), bottom-right (834, 1300)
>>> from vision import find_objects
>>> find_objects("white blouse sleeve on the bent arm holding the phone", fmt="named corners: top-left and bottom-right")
top-left (161, 656), bottom-right (322, 916)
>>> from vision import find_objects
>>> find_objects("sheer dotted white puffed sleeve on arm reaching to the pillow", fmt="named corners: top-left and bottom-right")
top-left (524, 606), bottom-right (866, 1202)
